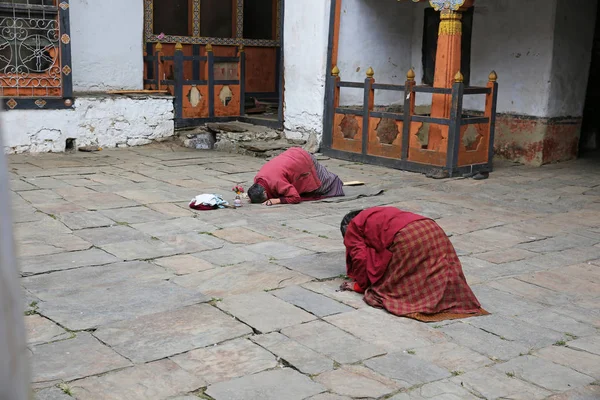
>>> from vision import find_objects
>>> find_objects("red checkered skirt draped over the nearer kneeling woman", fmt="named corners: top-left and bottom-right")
top-left (365, 219), bottom-right (487, 321)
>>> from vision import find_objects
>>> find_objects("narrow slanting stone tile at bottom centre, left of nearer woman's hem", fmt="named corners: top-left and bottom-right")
top-left (250, 332), bottom-right (333, 375)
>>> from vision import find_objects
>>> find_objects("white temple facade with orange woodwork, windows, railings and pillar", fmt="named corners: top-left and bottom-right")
top-left (0, 0), bottom-right (600, 166)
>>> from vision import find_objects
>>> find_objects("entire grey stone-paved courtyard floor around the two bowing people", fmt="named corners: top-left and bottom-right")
top-left (9, 144), bottom-right (600, 400)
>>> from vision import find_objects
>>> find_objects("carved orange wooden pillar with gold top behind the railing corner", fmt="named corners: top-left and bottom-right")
top-left (427, 0), bottom-right (473, 152)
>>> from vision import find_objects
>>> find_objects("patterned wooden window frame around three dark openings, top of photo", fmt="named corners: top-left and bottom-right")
top-left (144, 0), bottom-right (282, 47)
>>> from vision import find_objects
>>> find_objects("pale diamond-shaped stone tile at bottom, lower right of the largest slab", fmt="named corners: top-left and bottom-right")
top-left (172, 339), bottom-right (277, 384)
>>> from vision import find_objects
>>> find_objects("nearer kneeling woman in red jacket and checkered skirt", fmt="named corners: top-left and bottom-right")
top-left (341, 207), bottom-right (488, 322)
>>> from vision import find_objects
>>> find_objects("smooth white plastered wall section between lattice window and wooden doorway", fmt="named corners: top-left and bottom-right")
top-left (70, 0), bottom-right (144, 92)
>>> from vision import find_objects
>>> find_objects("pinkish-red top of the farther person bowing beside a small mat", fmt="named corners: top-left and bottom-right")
top-left (254, 147), bottom-right (321, 204)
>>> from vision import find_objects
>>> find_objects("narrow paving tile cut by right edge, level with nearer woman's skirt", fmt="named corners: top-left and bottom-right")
top-left (519, 270), bottom-right (600, 297)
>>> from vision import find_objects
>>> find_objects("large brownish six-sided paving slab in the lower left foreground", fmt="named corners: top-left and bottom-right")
top-left (94, 304), bottom-right (252, 363)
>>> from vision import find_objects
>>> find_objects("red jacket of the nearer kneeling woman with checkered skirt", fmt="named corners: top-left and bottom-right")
top-left (344, 207), bottom-right (428, 293)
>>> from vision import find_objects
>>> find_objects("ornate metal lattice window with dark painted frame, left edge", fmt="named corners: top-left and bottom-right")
top-left (0, 0), bottom-right (73, 109)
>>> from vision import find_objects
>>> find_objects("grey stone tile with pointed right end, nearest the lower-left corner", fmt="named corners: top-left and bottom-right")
top-left (32, 332), bottom-right (131, 383)
